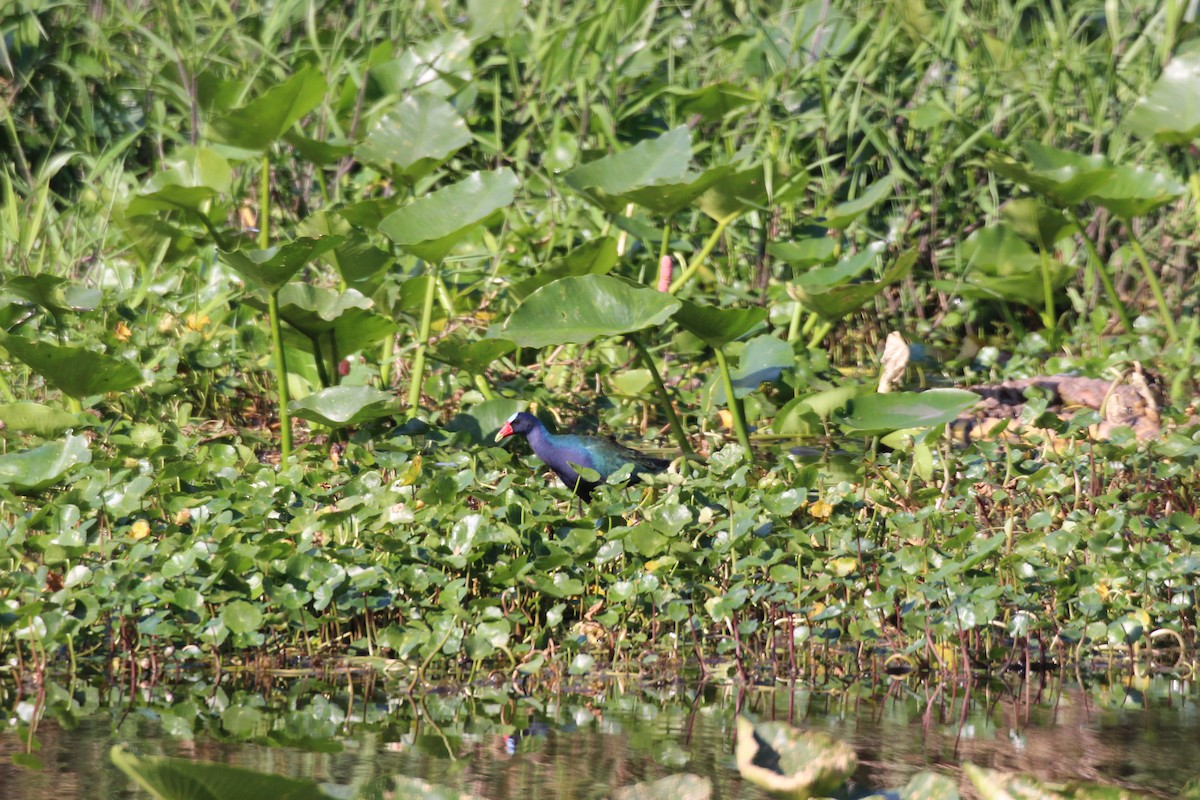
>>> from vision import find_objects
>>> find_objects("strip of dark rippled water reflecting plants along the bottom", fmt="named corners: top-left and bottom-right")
top-left (0, 675), bottom-right (1200, 800)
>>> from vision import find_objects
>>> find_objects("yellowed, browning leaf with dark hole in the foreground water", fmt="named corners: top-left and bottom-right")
top-left (734, 716), bottom-right (858, 800)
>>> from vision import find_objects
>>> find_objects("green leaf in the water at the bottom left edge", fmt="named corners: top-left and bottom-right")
top-left (109, 745), bottom-right (330, 800)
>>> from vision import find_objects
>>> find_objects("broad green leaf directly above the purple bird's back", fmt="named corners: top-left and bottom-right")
top-left (488, 275), bottom-right (686, 348)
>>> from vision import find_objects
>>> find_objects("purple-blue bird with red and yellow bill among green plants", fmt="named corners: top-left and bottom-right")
top-left (496, 411), bottom-right (670, 503)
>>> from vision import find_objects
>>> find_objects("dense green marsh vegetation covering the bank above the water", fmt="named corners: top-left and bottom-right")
top-left (0, 0), bottom-right (1200, 681)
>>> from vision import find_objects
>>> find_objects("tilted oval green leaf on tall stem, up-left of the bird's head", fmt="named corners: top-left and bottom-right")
top-left (379, 169), bottom-right (517, 261)
